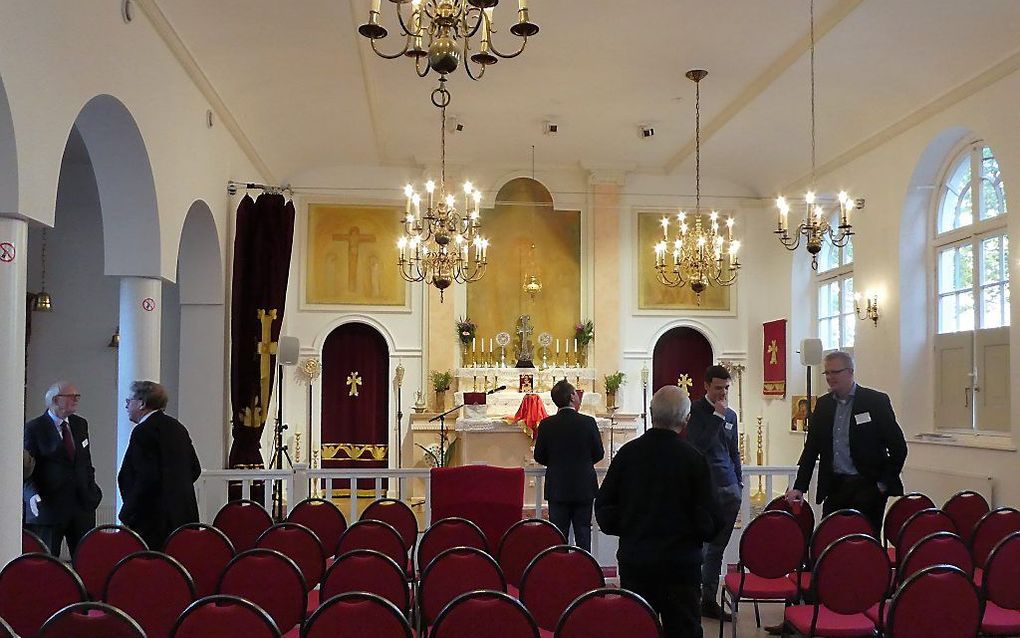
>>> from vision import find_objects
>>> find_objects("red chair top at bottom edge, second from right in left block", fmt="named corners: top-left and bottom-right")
top-left (429, 590), bottom-right (542, 638)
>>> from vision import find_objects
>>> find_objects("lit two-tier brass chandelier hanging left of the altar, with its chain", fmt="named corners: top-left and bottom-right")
top-left (397, 90), bottom-right (489, 303)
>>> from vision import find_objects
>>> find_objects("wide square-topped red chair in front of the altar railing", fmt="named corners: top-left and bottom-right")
top-left (430, 465), bottom-right (524, 547)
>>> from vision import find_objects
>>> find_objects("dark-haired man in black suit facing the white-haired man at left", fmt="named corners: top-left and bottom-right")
top-left (117, 381), bottom-right (202, 550)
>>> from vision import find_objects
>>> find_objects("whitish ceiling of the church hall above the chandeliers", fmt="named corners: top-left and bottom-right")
top-left (150, 0), bottom-right (1020, 195)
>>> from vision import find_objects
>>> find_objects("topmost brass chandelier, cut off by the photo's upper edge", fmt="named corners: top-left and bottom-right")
top-left (358, 0), bottom-right (539, 80)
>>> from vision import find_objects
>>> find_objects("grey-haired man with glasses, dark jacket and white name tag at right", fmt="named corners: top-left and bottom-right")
top-left (786, 352), bottom-right (907, 534)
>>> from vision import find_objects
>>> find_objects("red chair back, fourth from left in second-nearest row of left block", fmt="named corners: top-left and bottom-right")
top-left (319, 549), bottom-right (411, 615)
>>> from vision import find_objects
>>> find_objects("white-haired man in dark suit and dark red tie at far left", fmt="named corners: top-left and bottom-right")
top-left (21, 382), bottom-right (103, 555)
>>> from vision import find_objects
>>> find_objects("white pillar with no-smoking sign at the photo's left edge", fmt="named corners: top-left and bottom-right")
top-left (0, 216), bottom-right (29, 566)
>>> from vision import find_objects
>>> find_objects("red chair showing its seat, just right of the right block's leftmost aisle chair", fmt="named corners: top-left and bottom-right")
top-left (784, 534), bottom-right (891, 638)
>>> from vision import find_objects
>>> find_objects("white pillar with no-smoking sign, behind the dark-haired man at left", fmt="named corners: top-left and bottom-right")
top-left (117, 277), bottom-right (162, 512)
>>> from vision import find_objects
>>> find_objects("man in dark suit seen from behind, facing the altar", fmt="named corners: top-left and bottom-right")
top-left (534, 379), bottom-right (606, 551)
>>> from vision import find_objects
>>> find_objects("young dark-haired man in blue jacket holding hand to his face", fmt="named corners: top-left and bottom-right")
top-left (687, 365), bottom-right (744, 622)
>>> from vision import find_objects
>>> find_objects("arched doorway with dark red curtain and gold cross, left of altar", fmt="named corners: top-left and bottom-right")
top-left (319, 323), bottom-right (390, 497)
